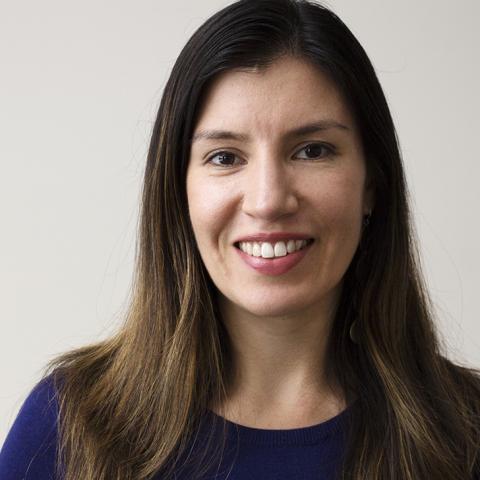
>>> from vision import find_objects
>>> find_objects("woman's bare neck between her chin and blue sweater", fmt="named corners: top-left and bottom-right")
top-left (212, 288), bottom-right (346, 428)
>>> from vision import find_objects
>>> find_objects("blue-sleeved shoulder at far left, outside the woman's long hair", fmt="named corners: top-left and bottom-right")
top-left (0, 376), bottom-right (58, 480)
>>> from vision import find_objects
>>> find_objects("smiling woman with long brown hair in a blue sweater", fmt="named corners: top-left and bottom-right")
top-left (0, 0), bottom-right (480, 480)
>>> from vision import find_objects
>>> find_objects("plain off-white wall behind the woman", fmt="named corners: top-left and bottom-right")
top-left (0, 0), bottom-right (480, 443)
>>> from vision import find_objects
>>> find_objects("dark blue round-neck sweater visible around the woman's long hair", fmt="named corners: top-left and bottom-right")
top-left (0, 378), bottom-right (352, 480)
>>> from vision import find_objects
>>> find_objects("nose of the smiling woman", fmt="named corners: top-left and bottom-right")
top-left (242, 155), bottom-right (298, 222)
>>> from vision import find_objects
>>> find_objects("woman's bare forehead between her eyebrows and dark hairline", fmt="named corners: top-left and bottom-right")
top-left (195, 57), bottom-right (353, 135)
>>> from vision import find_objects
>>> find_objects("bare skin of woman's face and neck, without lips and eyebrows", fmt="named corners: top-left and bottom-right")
top-left (187, 57), bottom-right (373, 429)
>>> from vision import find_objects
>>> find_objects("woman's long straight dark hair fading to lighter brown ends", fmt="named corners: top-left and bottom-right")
top-left (45, 0), bottom-right (480, 480)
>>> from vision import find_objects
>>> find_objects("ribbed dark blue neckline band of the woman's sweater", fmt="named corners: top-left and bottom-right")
top-left (204, 403), bottom-right (353, 446)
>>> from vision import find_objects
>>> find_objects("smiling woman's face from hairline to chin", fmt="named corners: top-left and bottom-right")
top-left (187, 57), bottom-right (373, 316)
